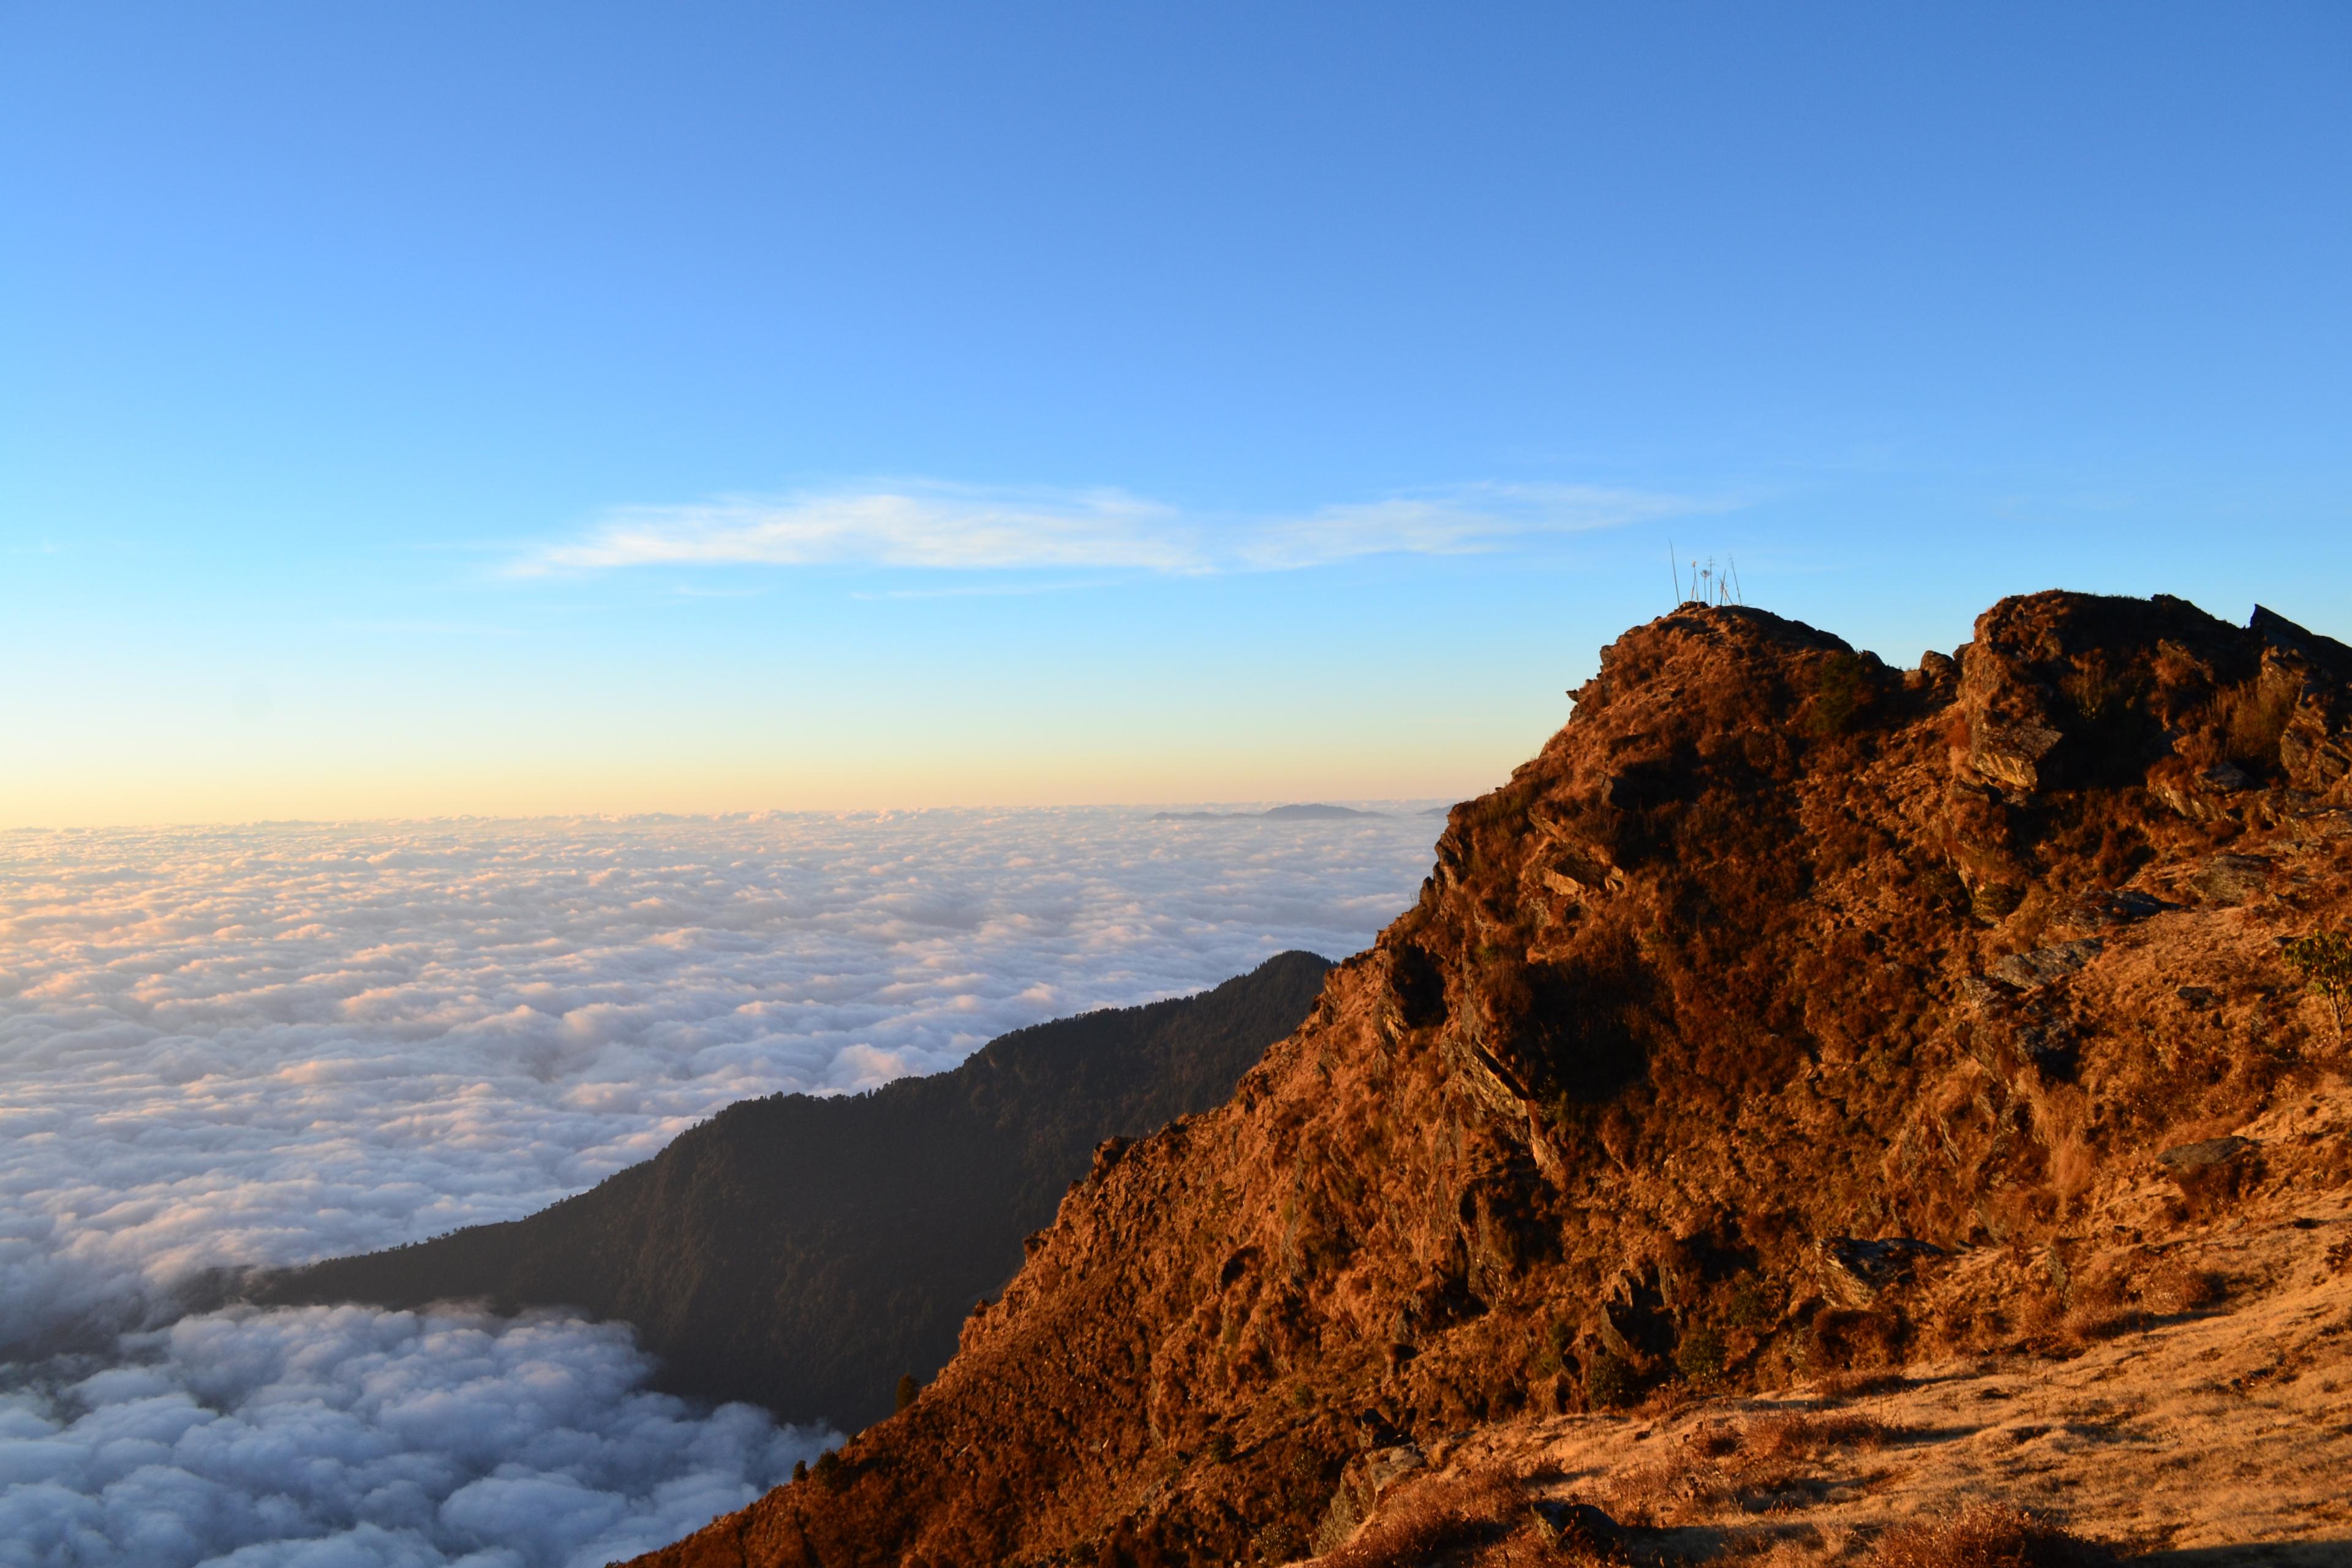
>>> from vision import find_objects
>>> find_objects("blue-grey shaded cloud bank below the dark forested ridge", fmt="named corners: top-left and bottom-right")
top-left (0, 1307), bottom-right (821, 1568)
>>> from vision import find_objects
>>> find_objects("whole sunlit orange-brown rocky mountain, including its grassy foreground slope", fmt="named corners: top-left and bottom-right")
top-left (642, 592), bottom-right (2352, 1568)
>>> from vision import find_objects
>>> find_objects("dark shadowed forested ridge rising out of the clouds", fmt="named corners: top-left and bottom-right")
top-left (244, 952), bottom-right (1329, 1427)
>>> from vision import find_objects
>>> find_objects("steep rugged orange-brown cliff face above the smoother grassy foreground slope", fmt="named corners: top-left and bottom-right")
top-left (647, 592), bottom-right (2352, 1568)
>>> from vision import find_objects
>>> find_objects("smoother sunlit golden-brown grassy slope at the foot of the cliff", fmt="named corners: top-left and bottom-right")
top-left (1322, 1081), bottom-right (2352, 1568)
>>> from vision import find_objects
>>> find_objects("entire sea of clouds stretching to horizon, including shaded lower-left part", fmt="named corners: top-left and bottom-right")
top-left (0, 809), bottom-right (1439, 1568)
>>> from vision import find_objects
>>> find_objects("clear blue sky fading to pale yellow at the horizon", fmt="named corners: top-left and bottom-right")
top-left (0, 5), bottom-right (2352, 823)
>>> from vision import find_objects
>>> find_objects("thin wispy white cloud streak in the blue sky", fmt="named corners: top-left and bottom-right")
top-left (510, 484), bottom-right (1727, 576)
